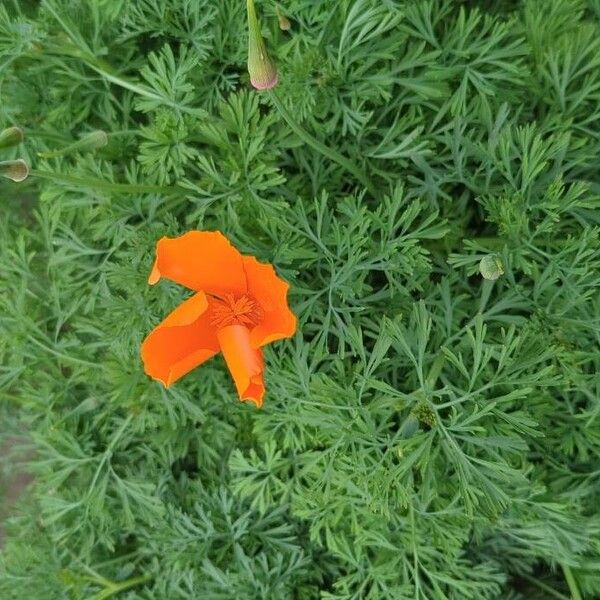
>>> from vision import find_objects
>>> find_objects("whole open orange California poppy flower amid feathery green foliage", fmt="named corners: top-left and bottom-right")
top-left (142, 231), bottom-right (296, 407)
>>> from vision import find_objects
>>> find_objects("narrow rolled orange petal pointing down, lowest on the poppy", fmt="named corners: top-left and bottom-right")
top-left (217, 325), bottom-right (265, 408)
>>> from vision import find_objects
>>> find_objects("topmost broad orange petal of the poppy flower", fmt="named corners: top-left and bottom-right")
top-left (148, 231), bottom-right (246, 296)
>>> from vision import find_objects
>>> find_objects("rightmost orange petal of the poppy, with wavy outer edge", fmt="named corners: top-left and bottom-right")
top-left (243, 256), bottom-right (296, 348)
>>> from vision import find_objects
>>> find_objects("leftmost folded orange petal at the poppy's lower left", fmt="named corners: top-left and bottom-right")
top-left (142, 292), bottom-right (219, 387)
